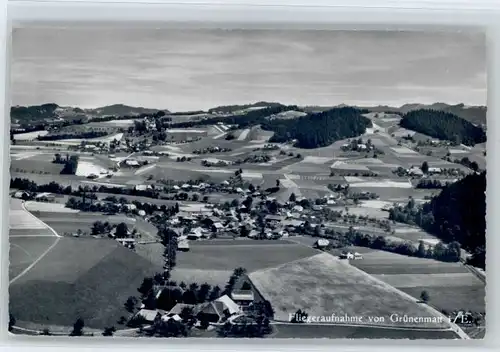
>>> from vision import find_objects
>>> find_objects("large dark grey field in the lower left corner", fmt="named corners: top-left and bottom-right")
top-left (9, 238), bottom-right (154, 329)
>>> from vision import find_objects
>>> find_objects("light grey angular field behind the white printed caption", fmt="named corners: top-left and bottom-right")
top-left (250, 253), bottom-right (446, 328)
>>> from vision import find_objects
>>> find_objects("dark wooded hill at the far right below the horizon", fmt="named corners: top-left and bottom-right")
top-left (400, 109), bottom-right (486, 146)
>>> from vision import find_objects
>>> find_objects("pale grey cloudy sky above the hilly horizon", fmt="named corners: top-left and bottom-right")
top-left (11, 27), bottom-right (486, 111)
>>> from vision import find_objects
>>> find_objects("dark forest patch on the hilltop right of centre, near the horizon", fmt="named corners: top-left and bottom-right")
top-left (262, 107), bottom-right (372, 148)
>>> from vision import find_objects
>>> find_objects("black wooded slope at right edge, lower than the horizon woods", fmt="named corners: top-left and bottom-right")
top-left (389, 171), bottom-right (486, 268)
